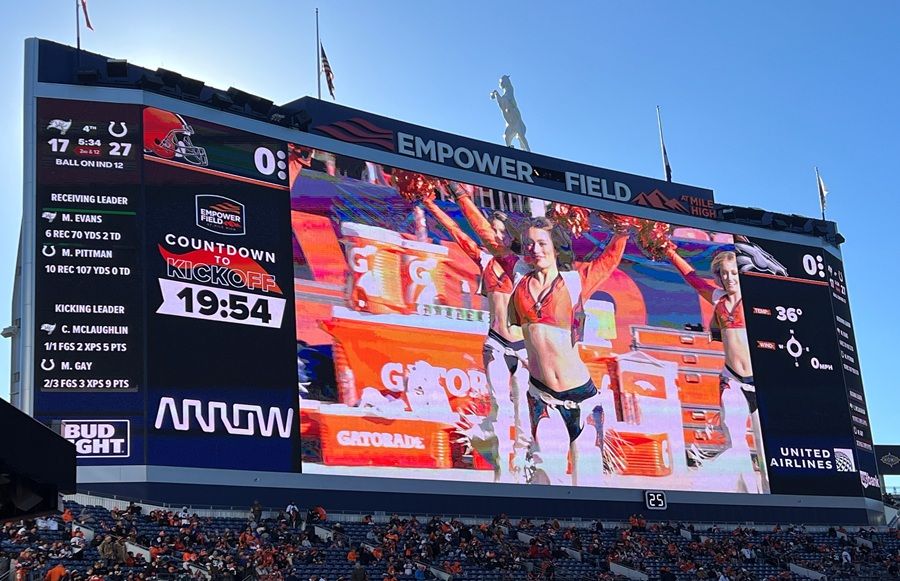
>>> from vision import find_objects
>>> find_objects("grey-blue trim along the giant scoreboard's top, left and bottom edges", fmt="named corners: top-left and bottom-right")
top-left (13, 39), bottom-right (882, 524)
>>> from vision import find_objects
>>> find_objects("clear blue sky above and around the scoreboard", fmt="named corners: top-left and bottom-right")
top-left (0, 0), bottom-right (900, 462)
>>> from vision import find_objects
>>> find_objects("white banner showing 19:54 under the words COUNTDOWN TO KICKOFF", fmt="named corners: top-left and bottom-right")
top-left (156, 279), bottom-right (285, 328)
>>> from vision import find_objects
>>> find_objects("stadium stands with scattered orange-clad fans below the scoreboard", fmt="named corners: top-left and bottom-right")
top-left (0, 501), bottom-right (900, 581)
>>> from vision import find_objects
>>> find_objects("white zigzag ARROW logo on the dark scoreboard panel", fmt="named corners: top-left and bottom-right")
top-left (154, 397), bottom-right (294, 438)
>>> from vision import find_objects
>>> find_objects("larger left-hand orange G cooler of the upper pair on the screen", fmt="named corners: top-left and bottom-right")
top-left (341, 222), bottom-right (406, 314)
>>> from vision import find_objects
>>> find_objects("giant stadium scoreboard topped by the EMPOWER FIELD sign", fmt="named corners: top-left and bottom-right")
top-left (12, 40), bottom-right (881, 522)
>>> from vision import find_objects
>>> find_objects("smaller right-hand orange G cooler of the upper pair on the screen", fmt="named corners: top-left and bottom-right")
top-left (402, 240), bottom-right (449, 312)
